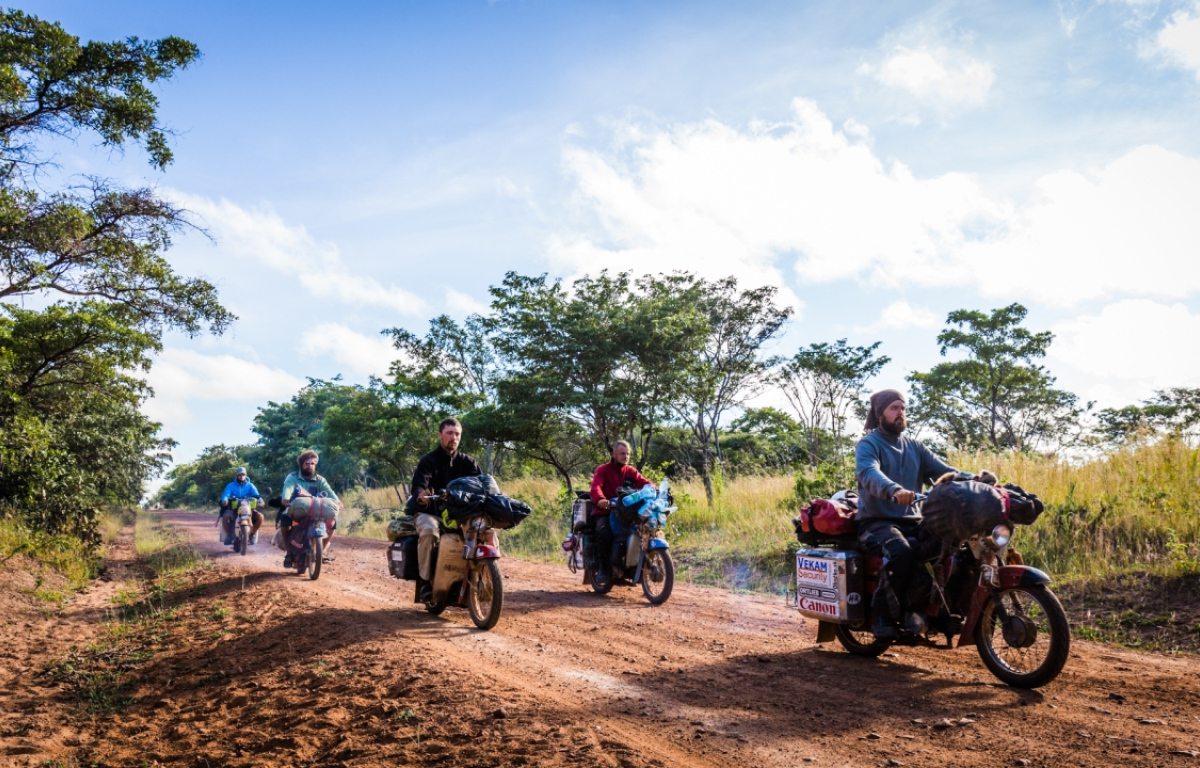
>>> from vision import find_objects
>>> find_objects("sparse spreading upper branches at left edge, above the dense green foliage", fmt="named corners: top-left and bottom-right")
top-left (0, 11), bottom-right (233, 334)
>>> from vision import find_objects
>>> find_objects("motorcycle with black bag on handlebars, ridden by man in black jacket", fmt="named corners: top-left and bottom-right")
top-left (388, 475), bottom-right (529, 630)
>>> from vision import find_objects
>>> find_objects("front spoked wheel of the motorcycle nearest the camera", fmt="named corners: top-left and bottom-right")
top-left (976, 584), bottom-right (1070, 688)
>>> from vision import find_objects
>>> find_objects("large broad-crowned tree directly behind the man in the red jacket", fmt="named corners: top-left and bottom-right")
top-left (486, 272), bottom-right (706, 472)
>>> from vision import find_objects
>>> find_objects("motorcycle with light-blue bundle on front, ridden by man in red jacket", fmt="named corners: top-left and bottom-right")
top-left (563, 480), bottom-right (678, 605)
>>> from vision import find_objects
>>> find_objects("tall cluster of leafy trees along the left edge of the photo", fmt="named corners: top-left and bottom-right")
top-left (0, 10), bottom-right (225, 540)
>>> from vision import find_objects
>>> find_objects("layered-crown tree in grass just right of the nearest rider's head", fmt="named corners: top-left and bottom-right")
top-left (908, 304), bottom-right (1084, 450)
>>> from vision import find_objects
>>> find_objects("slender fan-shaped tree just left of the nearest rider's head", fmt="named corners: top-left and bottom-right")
top-left (775, 338), bottom-right (892, 467)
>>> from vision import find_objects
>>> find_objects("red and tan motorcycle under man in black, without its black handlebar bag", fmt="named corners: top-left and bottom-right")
top-left (388, 493), bottom-right (504, 630)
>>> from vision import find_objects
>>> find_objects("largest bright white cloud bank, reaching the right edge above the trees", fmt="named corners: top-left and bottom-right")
top-left (548, 98), bottom-right (1200, 306)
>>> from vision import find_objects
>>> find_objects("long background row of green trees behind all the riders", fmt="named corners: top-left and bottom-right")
top-left (158, 272), bottom-right (1196, 513)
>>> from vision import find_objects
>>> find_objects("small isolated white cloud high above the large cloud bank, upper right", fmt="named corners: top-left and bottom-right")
top-left (860, 46), bottom-right (996, 109)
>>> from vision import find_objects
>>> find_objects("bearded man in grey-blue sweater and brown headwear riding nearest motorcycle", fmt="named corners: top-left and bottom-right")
top-left (854, 389), bottom-right (958, 640)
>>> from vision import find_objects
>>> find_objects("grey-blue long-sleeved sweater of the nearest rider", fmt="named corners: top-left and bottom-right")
top-left (854, 430), bottom-right (958, 521)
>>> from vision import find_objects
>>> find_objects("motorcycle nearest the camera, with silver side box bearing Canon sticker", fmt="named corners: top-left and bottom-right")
top-left (787, 494), bottom-right (1070, 688)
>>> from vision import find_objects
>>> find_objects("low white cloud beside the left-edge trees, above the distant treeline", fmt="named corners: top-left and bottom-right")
top-left (143, 349), bottom-right (305, 426)
